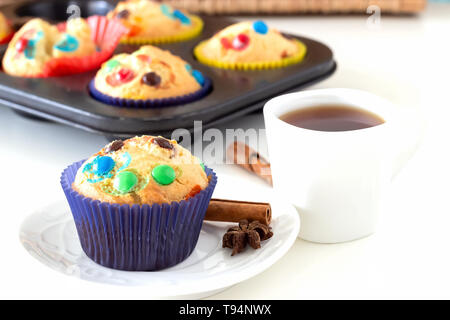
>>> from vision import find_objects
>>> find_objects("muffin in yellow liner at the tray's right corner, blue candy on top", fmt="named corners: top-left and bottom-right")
top-left (194, 20), bottom-right (306, 69)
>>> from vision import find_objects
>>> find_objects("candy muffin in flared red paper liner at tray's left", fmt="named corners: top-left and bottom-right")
top-left (3, 16), bottom-right (127, 77)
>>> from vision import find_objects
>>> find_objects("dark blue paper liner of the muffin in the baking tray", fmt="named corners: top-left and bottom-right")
top-left (89, 77), bottom-right (212, 109)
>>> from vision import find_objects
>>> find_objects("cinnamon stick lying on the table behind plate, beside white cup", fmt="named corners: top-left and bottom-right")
top-left (227, 141), bottom-right (272, 184)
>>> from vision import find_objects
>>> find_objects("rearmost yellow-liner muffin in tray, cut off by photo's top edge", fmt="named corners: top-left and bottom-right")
top-left (107, 0), bottom-right (203, 44)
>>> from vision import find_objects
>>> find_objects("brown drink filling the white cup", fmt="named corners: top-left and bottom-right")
top-left (280, 105), bottom-right (385, 131)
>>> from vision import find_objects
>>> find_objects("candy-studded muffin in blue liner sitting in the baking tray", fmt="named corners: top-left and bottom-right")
top-left (90, 45), bottom-right (212, 107)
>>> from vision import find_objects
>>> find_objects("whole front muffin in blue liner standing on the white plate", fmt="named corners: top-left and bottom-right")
top-left (61, 136), bottom-right (217, 270)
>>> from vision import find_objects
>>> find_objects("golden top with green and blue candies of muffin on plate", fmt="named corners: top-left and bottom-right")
top-left (72, 136), bottom-right (209, 205)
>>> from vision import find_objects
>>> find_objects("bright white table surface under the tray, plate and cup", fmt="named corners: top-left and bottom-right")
top-left (0, 4), bottom-right (450, 299)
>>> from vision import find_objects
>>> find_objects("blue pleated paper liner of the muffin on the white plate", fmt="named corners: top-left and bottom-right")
top-left (61, 161), bottom-right (217, 271)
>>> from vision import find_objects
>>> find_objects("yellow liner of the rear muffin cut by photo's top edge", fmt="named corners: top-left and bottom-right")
top-left (120, 16), bottom-right (204, 45)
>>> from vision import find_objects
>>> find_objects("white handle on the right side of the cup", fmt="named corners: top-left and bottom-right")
top-left (392, 110), bottom-right (426, 179)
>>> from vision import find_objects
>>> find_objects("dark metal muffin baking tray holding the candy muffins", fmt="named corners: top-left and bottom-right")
top-left (0, 0), bottom-right (336, 138)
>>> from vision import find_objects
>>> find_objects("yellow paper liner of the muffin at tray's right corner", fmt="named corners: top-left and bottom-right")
top-left (194, 39), bottom-right (307, 71)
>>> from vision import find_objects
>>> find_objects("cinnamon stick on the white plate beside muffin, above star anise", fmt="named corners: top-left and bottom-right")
top-left (205, 199), bottom-right (272, 226)
